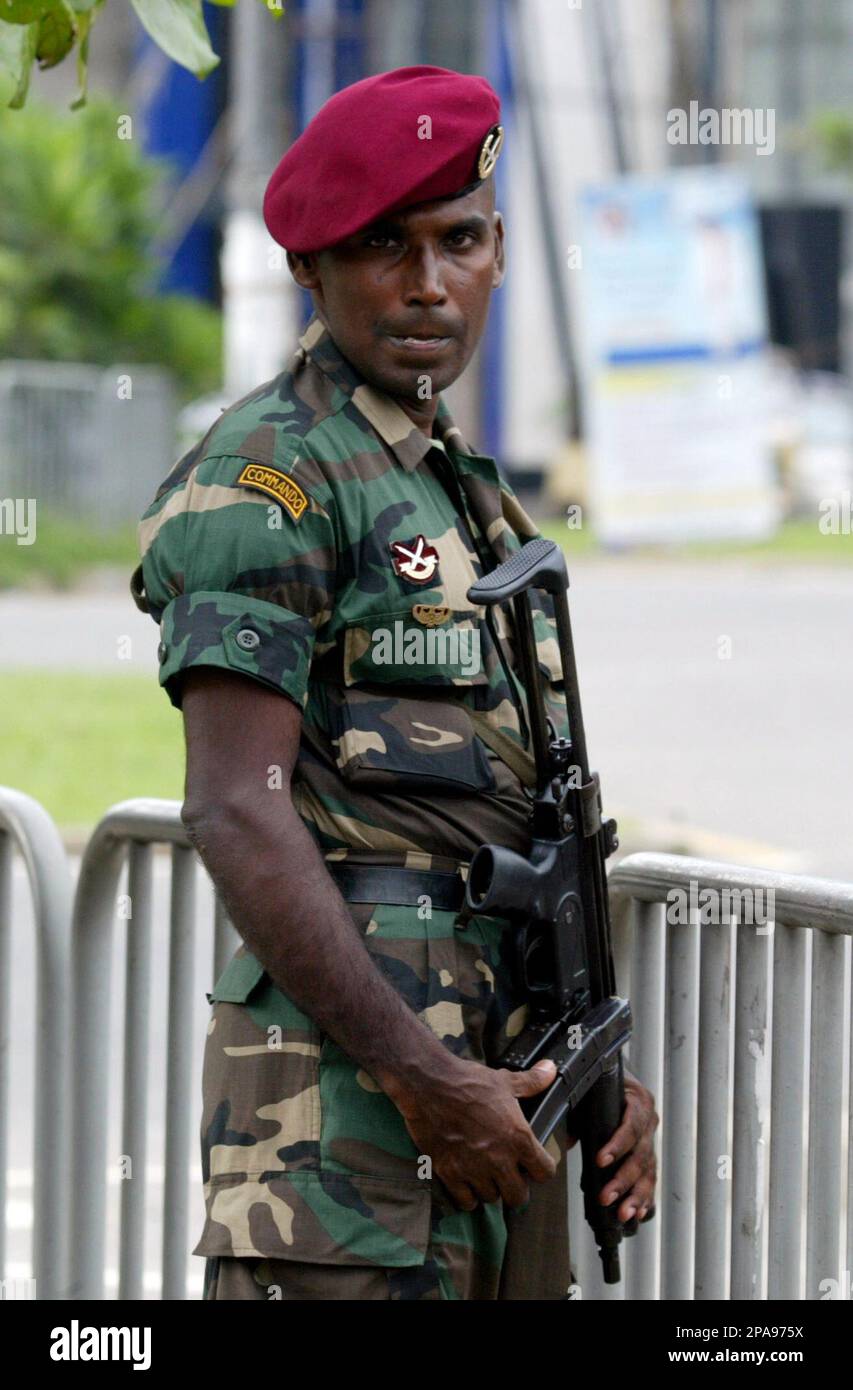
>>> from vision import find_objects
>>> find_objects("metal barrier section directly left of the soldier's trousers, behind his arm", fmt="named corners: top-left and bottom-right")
top-left (71, 799), bottom-right (239, 1298)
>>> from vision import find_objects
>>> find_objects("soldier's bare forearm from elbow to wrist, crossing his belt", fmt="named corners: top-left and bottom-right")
top-left (186, 799), bottom-right (453, 1098)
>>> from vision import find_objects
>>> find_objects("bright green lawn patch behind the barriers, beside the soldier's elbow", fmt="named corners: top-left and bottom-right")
top-left (0, 671), bottom-right (183, 830)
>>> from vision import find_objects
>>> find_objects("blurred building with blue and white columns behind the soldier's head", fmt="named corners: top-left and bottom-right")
top-left (23, 0), bottom-right (853, 497)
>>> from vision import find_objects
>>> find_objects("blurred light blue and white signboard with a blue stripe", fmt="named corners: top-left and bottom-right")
top-left (578, 168), bottom-right (781, 545)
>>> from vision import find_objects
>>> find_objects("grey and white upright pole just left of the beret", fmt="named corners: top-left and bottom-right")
top-left (221, 0), bottom-right (297, 402)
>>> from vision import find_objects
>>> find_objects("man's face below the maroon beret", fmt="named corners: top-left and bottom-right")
top-left (288, 179), bottom-right (504, 402)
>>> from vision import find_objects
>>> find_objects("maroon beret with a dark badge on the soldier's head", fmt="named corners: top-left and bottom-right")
top-left (264, 67), bottom-right (503, 253)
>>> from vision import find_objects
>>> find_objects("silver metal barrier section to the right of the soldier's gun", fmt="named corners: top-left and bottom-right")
top-left (572, 853), bottom-right (853, 1300)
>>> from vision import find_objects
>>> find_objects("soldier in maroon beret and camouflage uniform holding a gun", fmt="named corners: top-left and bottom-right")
top-left (132, 67), bottom-right (657, 1300)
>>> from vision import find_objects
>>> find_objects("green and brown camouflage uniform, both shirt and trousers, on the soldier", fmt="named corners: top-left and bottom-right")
top-left (132, 318), bottom-right (568, 1298)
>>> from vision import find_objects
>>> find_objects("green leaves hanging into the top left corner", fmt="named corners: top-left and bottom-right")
top-left (0, 0), bottom-right (285, 108)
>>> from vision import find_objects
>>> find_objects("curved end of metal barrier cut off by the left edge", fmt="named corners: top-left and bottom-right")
top-left (0, 787), bottom-right (71, 1298)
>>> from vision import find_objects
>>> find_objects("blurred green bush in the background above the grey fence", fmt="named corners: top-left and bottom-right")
top-left (0, 98), bottom-right (222, 399)
